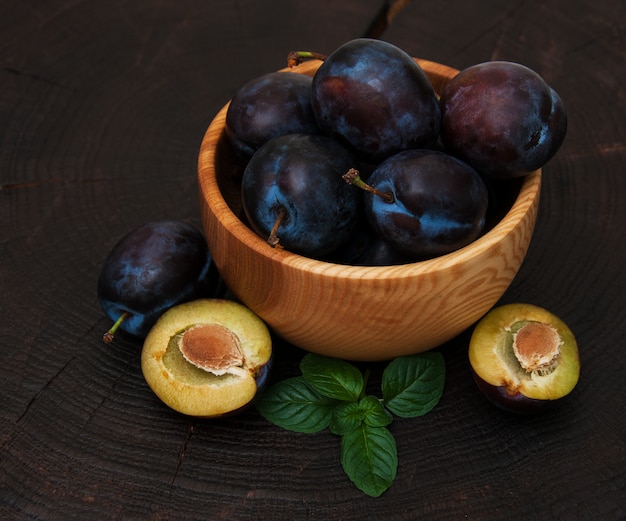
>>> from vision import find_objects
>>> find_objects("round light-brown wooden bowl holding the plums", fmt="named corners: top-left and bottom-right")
top-left (198, 60), bottom-right (541, 361)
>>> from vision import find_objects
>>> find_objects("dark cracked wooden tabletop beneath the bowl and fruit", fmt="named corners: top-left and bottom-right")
top-left (0, 0), bottom-right (626, 521)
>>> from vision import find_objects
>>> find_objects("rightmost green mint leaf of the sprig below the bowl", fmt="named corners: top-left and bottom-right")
top-left (382, 352), bottom-right (446, 418)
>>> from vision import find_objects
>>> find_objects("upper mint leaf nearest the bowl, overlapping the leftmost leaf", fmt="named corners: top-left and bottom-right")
top-left (300, 353), bottom-right (365, 401)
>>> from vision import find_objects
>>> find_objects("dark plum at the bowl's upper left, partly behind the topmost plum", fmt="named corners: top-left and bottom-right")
top-left (225, 72), bottom-right (320, 157)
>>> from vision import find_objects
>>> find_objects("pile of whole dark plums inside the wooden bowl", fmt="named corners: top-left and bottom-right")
top-left (226, 38), bottom-right (567, 265)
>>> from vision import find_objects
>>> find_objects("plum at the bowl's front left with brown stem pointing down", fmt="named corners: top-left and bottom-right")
top-left (242, 134), bottom-right (361, 257)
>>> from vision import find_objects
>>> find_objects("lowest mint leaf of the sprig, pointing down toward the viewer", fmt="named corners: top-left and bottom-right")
top-left (341, 423), bottom-right (398, 497)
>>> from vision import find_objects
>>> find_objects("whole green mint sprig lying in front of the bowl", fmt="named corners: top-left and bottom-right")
top-left (256, 352), bottom-right (445, 497)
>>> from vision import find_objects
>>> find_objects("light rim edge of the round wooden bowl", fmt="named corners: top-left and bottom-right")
top-left (198, 58), bottom-right (542, 279)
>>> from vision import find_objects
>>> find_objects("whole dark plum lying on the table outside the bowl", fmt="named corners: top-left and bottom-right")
top-left (98, 220), bottom-right (217, 341)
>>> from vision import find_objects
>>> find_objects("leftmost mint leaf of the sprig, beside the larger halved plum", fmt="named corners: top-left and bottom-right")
top-left (256, 376), bottom-right (337, 433)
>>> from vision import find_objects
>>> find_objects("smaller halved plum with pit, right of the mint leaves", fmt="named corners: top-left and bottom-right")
top-left (469, 304), bottom-right (580, 413)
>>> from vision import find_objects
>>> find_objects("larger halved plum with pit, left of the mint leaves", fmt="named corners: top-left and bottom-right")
top-left (141, 299), bottom-right (272, 418)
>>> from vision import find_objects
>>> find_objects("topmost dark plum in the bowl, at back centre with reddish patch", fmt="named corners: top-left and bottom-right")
top-left (311, 38), bottom-right (441, 162)
